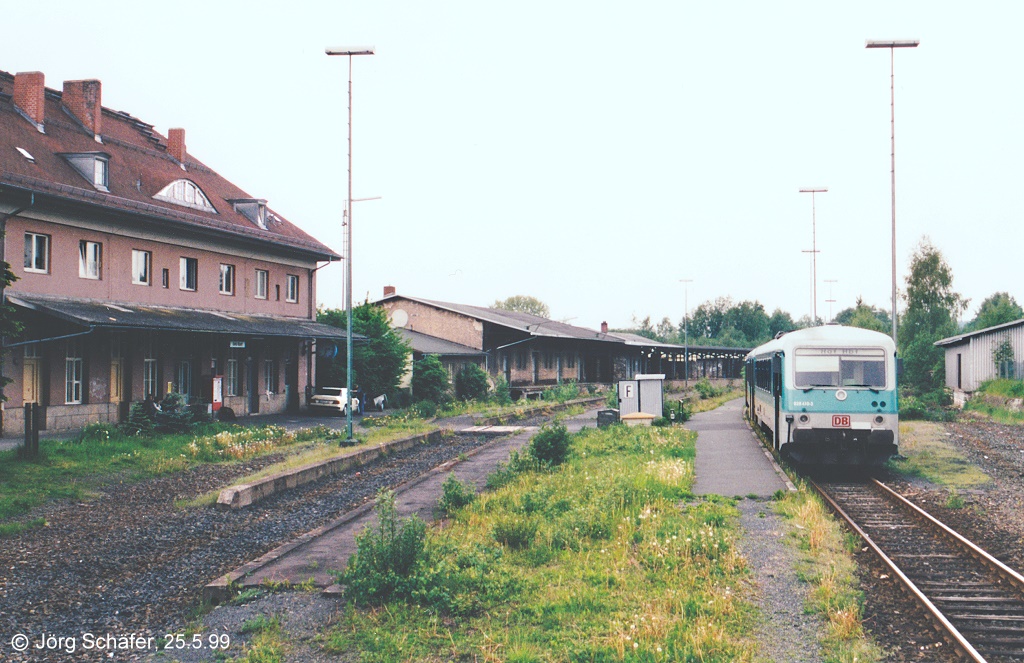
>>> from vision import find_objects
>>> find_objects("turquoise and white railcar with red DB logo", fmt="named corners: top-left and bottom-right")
top-left (744, 325), bottom-right (899, 466)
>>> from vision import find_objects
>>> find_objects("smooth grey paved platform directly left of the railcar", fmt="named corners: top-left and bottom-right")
top-left (686, 399), bottom-right (794, 497)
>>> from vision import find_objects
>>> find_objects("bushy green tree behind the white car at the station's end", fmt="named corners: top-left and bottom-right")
top-left (316, 303), bottom-right (412, 398)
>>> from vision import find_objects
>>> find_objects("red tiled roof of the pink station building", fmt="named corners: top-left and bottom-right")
top-left (0, 72), bottom-right (340, 260)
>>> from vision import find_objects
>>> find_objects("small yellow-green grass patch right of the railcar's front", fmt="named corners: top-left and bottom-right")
top-left (886, 421), bottom-right (992, 490)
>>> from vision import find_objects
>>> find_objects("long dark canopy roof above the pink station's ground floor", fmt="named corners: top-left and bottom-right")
top-left (7, 293), bottom-right (366, 340)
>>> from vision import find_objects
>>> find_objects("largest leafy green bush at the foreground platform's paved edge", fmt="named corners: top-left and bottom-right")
top-left (338, 490), bottom-right (427, 605)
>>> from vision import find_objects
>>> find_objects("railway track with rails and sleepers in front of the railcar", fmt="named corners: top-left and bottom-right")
top-left (812, 480), bottom-right (1024, 663)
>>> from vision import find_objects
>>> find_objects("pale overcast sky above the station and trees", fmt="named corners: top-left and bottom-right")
top-left (0, 0), bottom-right (1024, 328)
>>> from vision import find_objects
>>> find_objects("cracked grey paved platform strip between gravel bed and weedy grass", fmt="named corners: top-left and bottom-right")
top-left (233, 410), bottom-right (597, 587)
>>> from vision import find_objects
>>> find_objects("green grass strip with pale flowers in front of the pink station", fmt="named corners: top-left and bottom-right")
top-left (0, 424), bottom-right (348, 534)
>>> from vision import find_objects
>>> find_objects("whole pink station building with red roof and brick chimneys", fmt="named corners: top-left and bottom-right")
top-left (0, 72), bottom-right (344, 434)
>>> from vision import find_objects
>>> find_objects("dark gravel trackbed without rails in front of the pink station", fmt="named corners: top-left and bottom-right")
top-left (0, 422), bottom-right (544, 661)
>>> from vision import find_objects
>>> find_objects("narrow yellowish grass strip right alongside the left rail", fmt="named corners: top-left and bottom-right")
top-left (775, 485), bottom-right (884, 663)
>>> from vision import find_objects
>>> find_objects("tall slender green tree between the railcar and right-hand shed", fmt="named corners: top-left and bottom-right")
top-left (899, 237), bottom-right (968, 393)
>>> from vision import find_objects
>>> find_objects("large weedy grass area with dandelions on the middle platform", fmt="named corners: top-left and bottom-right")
top-left (321, 426), bottom-right (756, 662)
